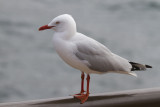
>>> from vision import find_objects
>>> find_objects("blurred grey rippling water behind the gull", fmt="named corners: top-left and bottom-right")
top-left (0, 0), bottom-right (160, 102)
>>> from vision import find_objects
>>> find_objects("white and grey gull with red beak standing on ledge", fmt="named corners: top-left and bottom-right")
top-left (39, 14), bottom-right (152, 104)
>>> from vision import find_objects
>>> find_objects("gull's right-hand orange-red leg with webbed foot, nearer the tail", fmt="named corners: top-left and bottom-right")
top-left (75, 74), bottom-right (90, 104)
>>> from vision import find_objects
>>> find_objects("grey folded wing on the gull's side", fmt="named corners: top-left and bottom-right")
top-left (75, 42), bottom-right (131, 72)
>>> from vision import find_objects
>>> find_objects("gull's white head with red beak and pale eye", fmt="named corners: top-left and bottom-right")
top-left (39, 14), bottom-right (76, 34)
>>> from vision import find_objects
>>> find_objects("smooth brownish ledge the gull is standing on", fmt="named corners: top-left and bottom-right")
top-left (0, 88), bottom-right (160, 107)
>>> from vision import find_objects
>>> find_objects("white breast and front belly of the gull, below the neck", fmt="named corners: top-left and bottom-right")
top-left (53, 36), bottom-right (90, 72)
